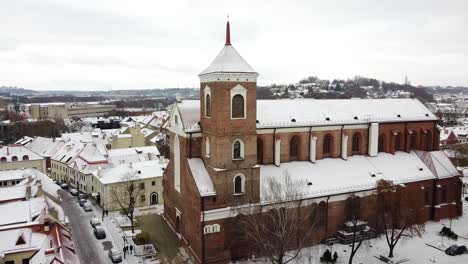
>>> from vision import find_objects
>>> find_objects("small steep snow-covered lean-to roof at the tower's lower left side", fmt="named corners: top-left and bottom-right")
top-left (187, 158), bottom-right (216, 197)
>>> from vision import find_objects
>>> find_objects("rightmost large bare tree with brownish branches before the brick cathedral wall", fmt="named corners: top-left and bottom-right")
top-left (377, 180), bottom-right (425, 258)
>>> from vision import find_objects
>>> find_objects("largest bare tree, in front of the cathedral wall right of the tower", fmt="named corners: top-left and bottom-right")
top-left (237, 173), bottom-right (318, 264)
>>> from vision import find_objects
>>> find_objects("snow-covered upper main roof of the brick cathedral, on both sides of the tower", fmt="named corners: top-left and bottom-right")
top-left (177, 98), bottom-right (437, 129)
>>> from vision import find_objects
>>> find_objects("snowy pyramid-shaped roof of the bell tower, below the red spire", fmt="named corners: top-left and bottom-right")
top-left (199, 45), bottom-right (258, 76)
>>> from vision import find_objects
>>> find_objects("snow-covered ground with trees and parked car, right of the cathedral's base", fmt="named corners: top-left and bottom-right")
top-left (239, 201), bottom-right (468, 264)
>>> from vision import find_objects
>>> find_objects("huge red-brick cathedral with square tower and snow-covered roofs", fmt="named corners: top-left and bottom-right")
top-left (163, 22), bottom-right (462, 263)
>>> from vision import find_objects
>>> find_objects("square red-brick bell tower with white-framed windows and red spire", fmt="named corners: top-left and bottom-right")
top-left (199, 21), bottom-right (259, 204)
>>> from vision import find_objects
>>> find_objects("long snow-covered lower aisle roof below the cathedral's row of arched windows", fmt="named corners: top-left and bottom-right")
top-left (260, 151), bottom-right (458, 202)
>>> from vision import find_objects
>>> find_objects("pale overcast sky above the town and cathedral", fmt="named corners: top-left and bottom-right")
top-left (0, 0), bottom-right (468, 90)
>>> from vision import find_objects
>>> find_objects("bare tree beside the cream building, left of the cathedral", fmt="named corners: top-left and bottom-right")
top-left (112, 171), bottom-right (142, 233)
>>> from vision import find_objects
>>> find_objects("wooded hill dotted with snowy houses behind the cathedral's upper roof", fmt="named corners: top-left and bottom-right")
top-left (257, 76), bottom-right (434, 103)
